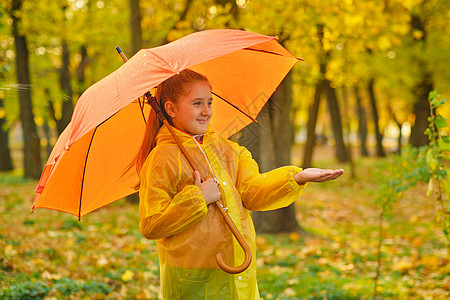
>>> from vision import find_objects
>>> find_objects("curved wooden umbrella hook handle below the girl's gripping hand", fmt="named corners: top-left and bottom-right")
top-left (216, 201), bottom-right (252, 274)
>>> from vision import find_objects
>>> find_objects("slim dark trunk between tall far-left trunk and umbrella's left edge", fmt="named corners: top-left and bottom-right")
top-left (55, 39), bottom-right (73, 134)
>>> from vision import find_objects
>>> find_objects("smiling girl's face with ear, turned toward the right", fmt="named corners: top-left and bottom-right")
top-left (165, 80), bottom-right (212, 135)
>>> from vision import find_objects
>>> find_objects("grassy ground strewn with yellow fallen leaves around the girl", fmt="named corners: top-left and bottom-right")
top-left (0, 154), bottom-right (450, 299)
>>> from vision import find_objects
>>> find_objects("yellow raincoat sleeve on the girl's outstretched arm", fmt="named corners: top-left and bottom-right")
top-left (237, 146), bottom-right (306, 211)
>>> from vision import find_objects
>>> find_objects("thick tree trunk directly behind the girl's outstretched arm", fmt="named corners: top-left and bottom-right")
top-left (241, 74), bottom-right (302, 233)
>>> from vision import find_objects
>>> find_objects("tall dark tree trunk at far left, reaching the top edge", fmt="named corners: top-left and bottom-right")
top-left (11, 0), bottom-right (41, 179)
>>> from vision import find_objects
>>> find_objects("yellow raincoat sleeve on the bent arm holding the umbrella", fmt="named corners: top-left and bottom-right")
top-left (139, 150), bottom-right (208, 239)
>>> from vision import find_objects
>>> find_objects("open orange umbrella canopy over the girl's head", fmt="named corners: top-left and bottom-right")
top-left (33, 29), bottom-right (299, 217)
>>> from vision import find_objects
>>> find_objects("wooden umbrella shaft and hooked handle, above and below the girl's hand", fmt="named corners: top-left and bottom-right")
top-left (145, 93), bottom-right (252, 274)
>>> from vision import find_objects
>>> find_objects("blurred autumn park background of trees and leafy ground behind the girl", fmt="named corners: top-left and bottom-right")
top-left (0, 0), bottom-right (450, 299)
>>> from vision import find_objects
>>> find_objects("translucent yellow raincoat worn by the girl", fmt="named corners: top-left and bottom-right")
top-left (139, 125), bottom-right (304, 300)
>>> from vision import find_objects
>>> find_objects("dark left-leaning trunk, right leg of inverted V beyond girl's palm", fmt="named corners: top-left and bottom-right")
top-left (325, 79), bottom-right (349, 162)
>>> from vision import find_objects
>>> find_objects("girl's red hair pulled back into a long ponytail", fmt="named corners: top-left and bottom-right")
top-left (130, 69), bottom-right (209, 182)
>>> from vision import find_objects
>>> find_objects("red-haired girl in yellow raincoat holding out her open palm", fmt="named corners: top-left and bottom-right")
top-left (136, 70), bottom-right (343, 300)
